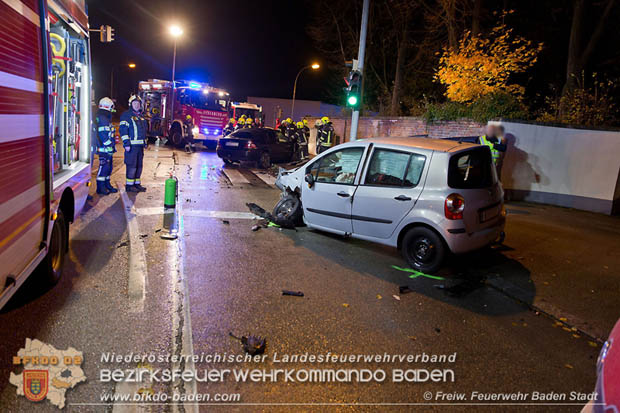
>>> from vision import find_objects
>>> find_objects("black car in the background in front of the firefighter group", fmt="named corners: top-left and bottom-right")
top-left (217, 128), bottom-right (295, 168)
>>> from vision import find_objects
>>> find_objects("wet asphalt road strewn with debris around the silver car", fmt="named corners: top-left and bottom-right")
top-left (0, 146), bottom-right (620, 412)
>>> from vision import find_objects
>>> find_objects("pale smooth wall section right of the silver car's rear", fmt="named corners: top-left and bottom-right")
top-left (501, 122), bottom-right (620, 214)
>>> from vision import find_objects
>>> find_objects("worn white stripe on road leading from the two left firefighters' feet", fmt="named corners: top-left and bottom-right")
top-left (117, 183), bottom-right (147, 312)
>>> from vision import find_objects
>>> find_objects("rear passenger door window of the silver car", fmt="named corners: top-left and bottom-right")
top-left (364, 149), bottom-right (426, 187)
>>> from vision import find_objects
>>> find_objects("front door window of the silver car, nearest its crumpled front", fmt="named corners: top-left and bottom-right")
top-left (311, 148), bottom-right (364, 185)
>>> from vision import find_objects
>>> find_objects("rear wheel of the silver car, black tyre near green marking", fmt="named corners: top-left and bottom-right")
top-left (402, 227), bottom-right (446, 273)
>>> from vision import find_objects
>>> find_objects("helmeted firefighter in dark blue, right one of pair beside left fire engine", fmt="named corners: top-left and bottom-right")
top-left (120, 95), bottom-right (148, 192)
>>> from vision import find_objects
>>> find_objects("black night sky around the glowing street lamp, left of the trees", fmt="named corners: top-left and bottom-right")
top-left (87, 0), bottom-right (330, 105)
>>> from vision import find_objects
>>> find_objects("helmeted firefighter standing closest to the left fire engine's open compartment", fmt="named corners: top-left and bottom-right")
top-left (96, 97), bottom-right (118, 195)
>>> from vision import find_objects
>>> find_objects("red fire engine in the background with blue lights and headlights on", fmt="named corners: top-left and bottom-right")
top-left (139, 79), bottom-right (230, 146)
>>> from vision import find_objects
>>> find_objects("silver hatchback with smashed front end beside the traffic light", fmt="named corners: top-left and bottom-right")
top-left (273, 138), bottom-right (506, 273)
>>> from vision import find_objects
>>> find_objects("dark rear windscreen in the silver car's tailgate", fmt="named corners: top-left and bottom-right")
top-left (448, 146), bottom-right (494, 189)
